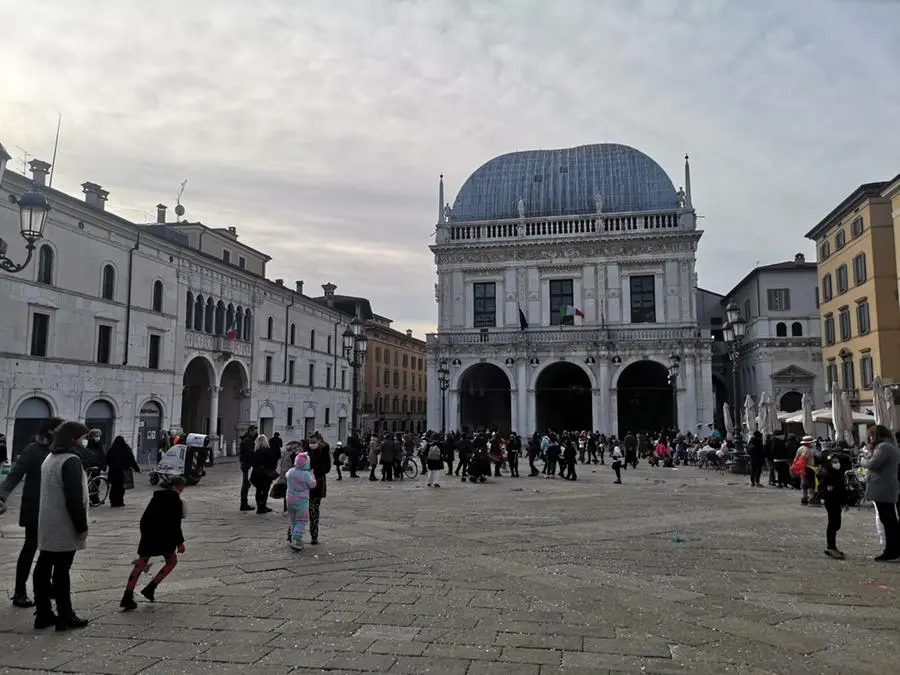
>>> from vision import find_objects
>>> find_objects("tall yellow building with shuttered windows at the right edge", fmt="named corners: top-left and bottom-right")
top-left (806, 177), bottom-right (900, 407)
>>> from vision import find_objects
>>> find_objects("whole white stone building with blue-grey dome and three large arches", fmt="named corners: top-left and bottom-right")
top-left (427, 144), bottom-right (715, 434)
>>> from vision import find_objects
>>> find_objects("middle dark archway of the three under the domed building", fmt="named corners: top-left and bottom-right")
top-left (534, 361), bottom-right (594, 433)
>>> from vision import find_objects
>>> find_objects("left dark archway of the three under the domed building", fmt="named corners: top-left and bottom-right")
top-left (460, 363), bottom-right (512, 433)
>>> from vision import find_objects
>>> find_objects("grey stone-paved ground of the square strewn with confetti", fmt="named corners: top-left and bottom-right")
top-left (0, 464), bottom-right (900, 675)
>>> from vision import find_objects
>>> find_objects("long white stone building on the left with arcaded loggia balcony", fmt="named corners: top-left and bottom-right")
top-left (0, 160), bottom-right (358, 459)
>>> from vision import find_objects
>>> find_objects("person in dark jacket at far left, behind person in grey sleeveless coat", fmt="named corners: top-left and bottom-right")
top-left (0, 417), bottom-right (63, 608)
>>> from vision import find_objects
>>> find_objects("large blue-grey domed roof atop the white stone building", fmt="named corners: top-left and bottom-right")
top-left (450, 143), bottom-right (677, 221)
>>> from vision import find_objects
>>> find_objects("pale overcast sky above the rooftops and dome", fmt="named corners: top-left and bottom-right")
top-left (0, 0), bottom-right (900, 334)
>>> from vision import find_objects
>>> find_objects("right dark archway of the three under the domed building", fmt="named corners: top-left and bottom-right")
top-left (616, 359), bottom-right (676, 438)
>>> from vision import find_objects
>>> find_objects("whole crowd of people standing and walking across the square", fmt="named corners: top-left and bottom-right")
top-left (0, 419), bottom-right (900, 631)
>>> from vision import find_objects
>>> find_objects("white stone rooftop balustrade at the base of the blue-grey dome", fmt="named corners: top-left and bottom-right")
top-left (438, 210), bottom-right (696, 244)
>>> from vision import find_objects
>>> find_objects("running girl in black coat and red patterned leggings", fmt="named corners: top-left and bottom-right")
top-left (119, 476), bottom-right (186, 612)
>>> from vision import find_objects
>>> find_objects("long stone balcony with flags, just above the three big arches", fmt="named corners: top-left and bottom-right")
top-left (425, 325), bottom-right (711, 348)
